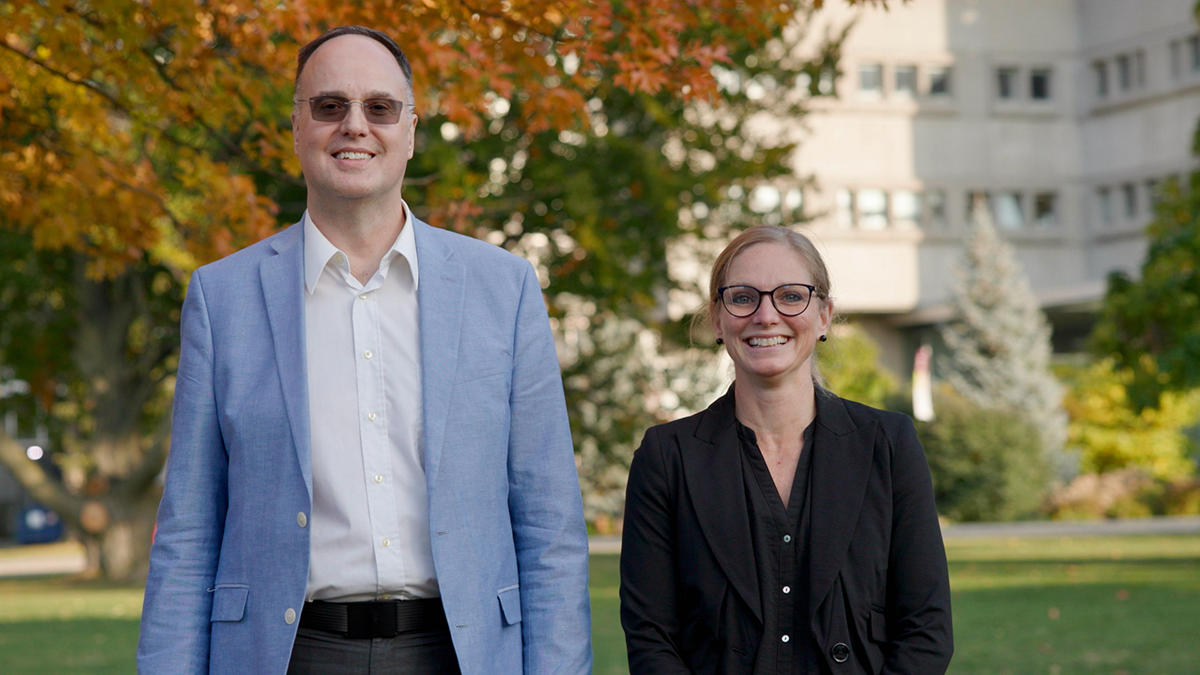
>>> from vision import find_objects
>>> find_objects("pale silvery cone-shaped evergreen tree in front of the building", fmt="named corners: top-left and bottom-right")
top-left (942, 195), bottom-right (1067, 467)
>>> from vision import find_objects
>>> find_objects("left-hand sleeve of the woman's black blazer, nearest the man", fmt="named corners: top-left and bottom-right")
top-left (620, 428), bottom-right (691, 675)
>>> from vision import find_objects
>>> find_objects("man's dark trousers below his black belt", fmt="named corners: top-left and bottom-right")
top-left (288, 628), bottom-right (460, 675)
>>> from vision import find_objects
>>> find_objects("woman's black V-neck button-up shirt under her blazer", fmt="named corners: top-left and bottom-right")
top-left (737, 422), bottom-right (821, 675)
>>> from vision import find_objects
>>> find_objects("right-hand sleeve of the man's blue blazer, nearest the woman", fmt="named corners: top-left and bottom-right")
top-left (508, 258), bottom-right (592, 674)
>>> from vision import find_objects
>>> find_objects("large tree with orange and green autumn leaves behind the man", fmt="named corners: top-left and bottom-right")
top-left (0, 0), bottom-right (883, 578)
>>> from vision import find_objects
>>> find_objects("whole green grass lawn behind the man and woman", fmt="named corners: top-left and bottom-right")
top-left (0, 536), bottom-right (1200, 675)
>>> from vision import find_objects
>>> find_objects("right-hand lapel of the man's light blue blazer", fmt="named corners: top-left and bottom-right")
top-left (410, 217), bottom-right (466, 485)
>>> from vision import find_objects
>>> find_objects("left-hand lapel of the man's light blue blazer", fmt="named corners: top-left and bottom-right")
top-left (259, 221), bottom-right (312, 500)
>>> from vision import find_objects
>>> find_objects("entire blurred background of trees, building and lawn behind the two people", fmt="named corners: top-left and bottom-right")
top-left (0, 0), bottom-right (1200, 674)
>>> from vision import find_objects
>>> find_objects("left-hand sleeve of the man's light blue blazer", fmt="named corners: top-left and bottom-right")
top-left (138, 271), bottom-right (228, 674)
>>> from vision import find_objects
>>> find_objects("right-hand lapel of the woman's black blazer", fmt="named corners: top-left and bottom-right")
top-left (809, 392), bottom-right (875, 616)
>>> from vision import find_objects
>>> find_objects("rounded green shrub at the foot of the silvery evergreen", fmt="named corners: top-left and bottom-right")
top-left (917, 389), bottom-right (1048, 521)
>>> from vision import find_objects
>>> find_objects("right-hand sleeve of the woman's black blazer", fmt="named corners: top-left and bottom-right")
top-left (883, 416), bottom-right (954, 675)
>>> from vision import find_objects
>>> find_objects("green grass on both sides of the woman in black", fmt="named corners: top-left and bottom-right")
top-left (592, 536), bottom-right (1200, 675)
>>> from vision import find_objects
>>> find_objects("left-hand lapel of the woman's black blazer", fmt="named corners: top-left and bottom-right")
top-left (680, 388), bottom-right (762, 622)
